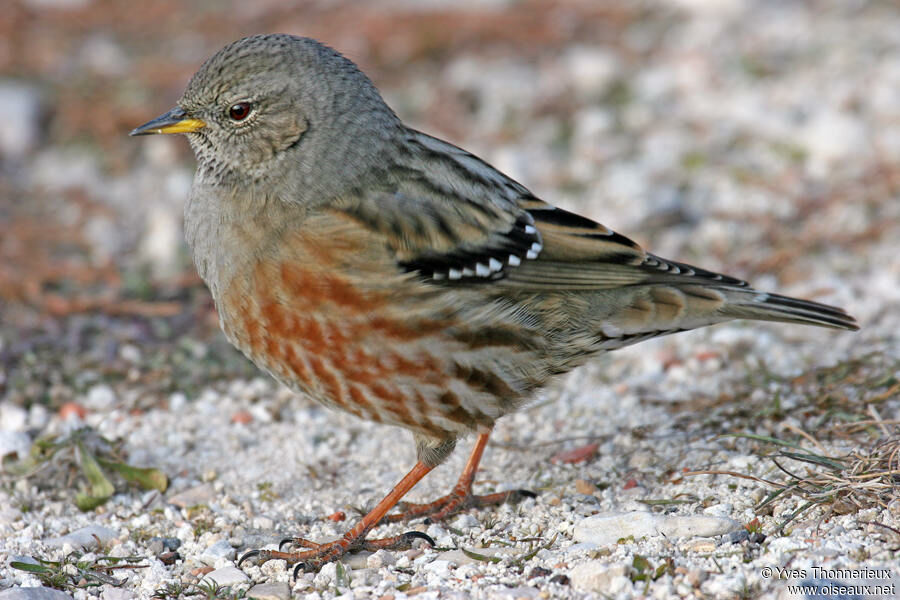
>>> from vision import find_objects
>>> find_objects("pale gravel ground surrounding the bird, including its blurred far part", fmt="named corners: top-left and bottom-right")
top-left (0, 0), bottom-right (900, 600)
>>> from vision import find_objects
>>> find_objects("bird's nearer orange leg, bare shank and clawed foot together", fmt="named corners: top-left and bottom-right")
top-left (238, 462), bottom-right (434, 576)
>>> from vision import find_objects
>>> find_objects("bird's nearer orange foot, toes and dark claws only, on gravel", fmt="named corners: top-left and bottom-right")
top-left (237, 531), bottom-right (435, 579)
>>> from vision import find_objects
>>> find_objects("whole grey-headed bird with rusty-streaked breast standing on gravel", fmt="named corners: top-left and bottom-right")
top-left (131, 34), bottom-right (858, 575)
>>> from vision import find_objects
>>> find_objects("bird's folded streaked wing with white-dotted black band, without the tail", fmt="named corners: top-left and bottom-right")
top-left (339, 130), bottom-right (652, 289)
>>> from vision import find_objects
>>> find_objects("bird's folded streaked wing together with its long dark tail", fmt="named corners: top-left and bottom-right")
top-left (340, 131), bottom-right (856, 330)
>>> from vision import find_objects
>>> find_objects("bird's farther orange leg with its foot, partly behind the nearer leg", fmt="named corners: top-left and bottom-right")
top-left (381, 432), bottom-right (535, 523)
